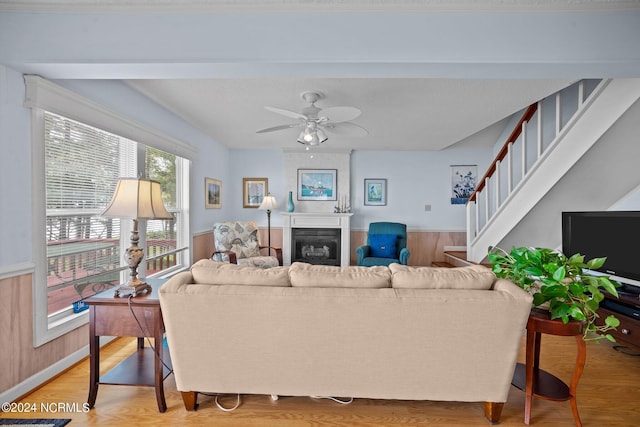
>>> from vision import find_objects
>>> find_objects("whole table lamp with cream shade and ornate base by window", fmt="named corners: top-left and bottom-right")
top-left (100, 178), bottom-right (173, 297)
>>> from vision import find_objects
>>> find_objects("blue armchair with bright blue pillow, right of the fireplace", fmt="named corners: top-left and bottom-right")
top-left (356, 222), bottom-right (410, 267)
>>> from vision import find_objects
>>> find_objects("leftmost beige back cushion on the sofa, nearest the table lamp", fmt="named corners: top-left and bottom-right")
top-left (191, 259), bottom-right (291, 286)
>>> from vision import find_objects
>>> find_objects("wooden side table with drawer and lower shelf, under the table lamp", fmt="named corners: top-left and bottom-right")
top-left (86, 279), bottom-right (172, 412)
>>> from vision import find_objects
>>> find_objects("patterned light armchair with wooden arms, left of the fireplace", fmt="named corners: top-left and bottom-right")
top-left (211, 221), bottom-right (282, 268)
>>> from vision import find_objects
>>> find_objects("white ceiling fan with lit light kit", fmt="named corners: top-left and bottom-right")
top-left (256, 91), bottom-right (369, 146)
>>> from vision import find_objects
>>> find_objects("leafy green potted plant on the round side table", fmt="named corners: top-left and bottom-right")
top-left (488, 247), bottom-right (620, 342)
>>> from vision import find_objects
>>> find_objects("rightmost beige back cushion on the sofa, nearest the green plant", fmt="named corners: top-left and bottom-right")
top-left (389, 264), bottom-right (496, 290)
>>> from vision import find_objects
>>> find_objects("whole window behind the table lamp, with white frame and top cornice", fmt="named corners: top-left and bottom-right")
top-left (25, 76), bottom-right (194, 346)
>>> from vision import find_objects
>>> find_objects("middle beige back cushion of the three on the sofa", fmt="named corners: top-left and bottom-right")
top-left (289, 262), bottom-right (391, 288)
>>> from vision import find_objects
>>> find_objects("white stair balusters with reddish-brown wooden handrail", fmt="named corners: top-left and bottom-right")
top-left (466, 80), bottom-right (610, 259)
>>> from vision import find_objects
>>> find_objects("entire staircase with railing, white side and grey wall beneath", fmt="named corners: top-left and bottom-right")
top-left (466, 79), bottom-right (640, 263)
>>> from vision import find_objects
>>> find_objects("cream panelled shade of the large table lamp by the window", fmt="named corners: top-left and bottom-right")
top-left (100, 178), bottom-right (173, 219)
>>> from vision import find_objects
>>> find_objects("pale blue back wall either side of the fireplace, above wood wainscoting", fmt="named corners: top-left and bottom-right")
top-left (221, 148), bottom-right (493, 231)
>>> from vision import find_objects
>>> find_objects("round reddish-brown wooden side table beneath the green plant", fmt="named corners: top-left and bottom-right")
top-left (512, 309), bottom-right (587, 427)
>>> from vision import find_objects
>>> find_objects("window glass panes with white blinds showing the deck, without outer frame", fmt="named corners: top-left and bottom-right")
top-left (44, 111), bottom-right (182, 315)
